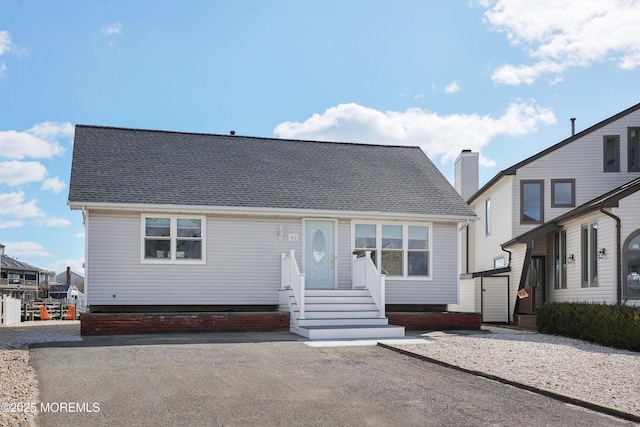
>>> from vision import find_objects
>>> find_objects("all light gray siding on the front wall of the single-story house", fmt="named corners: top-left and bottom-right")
top-left (86, 211), bottom-right (458, 305)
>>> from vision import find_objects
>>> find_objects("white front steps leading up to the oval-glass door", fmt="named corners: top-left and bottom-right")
top-left (289, 289), bottom-right (405, 340)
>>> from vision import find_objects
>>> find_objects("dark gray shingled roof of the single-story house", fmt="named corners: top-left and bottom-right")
top-left (69, 125), bottom-right (474, 217)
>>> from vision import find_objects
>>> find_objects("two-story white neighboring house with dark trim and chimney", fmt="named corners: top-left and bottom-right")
top-left (453, 104), bottom-right (640, 322)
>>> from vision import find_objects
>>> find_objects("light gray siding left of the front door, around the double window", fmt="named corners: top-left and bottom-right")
top-left (87, 212), bottom-right (302, 305)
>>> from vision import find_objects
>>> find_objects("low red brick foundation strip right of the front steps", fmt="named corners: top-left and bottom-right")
top-left (387, 311), bottom-right (482, 331)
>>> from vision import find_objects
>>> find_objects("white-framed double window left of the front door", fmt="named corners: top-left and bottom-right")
top-left (142, 215), bottom-right (205, 264)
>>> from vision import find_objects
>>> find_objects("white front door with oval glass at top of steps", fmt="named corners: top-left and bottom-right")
top-left (304, 220), bottom-right (336, 289)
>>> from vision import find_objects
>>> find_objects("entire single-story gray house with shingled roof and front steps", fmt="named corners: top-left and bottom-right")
top-left (69, 125), bottom-right (474, 338)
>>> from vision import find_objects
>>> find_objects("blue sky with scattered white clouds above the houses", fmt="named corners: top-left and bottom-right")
top-left (0, 0), bottom-right (640, 274)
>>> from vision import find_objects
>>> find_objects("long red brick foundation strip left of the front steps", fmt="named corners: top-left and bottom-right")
top-left (80, 311), bottom-right (289, 335)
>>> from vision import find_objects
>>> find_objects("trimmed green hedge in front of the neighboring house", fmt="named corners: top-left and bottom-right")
top-left (536, 302), bottom-right (640, 352)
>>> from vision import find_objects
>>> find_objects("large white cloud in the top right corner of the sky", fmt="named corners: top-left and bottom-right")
top-left (482, 0), bottom-right (640, 85)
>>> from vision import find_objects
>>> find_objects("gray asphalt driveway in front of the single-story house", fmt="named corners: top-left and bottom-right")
top-left (30, 333), bottom-right (632, 427)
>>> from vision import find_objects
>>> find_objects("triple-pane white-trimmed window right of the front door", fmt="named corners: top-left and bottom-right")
top-left (353, 223), bottom-right (431, 278)
